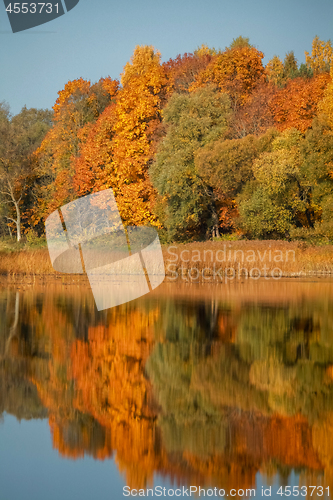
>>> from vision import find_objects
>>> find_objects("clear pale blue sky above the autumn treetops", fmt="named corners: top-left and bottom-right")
top-left (0, 0), bottom-right (333, 114)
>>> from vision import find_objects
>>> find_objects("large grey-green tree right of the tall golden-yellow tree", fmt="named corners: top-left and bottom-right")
top-left (150, 86), bottom-right (230, 240)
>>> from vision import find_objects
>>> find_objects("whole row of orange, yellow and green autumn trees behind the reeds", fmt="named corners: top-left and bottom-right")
top-left (0, 37), bottom-right (333, 242)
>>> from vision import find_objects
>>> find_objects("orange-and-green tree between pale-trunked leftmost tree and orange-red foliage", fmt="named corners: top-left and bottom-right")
top-left (32, 78), bottom-right (117, 224)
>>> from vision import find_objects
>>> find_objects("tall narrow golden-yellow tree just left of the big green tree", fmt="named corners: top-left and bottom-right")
top-left (96, 46), bottom-right (168, 225)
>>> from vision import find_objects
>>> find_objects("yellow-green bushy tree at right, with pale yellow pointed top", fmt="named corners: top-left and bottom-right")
top-left (239, 129), bottom-right (315, 238)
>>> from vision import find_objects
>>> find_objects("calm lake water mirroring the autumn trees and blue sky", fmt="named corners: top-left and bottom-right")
top-left (0, 280), bottom-right (333, 500)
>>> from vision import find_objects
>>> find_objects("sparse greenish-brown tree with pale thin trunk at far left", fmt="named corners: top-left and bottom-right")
top-left (0, 104), bottom-right (52, 241)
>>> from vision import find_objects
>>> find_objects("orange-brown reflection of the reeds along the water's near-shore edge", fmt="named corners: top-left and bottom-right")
top-left (0, 276), bottom-right (333, 311)
